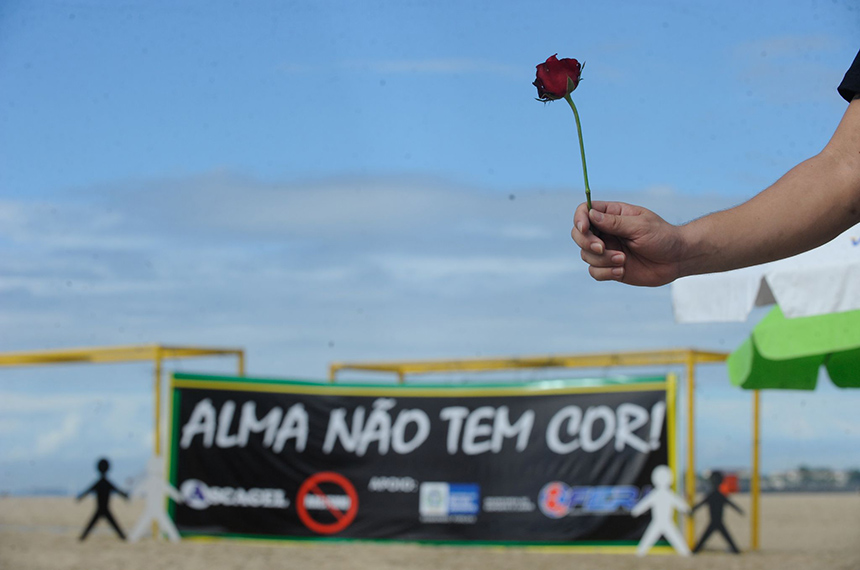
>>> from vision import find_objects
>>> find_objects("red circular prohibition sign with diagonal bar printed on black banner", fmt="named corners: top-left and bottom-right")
top-left (296, 471), bottom-right (358, 534)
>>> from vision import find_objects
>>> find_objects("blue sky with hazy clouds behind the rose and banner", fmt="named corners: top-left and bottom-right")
top-left (0, 0), bottom-right (860, 490)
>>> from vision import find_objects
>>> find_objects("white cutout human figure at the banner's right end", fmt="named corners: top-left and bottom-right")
top-left (630, 465), bottom-right (690, 556)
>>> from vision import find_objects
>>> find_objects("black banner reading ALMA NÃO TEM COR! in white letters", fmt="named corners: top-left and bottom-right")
top-left (170, 374), bottom-right (672, 545)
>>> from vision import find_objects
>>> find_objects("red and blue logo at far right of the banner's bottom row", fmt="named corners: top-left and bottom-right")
top-left (538, 481), bottom-right (643, 519)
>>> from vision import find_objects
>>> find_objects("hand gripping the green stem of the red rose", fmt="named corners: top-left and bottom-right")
top-left (570, 201), bottom-right (683, 287)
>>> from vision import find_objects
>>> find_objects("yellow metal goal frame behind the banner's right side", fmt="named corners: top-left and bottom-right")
top-left (329, 348), bottom-right (759, 550)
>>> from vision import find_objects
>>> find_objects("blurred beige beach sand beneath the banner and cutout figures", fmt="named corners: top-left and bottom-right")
top-left (0, 494), bottom-right (860, 570)
